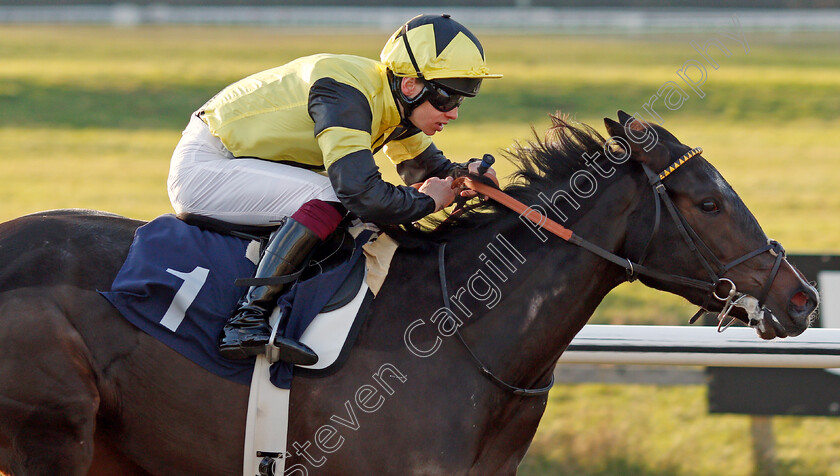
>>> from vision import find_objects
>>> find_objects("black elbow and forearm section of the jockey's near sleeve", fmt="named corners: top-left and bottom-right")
top-left (327, 150), bottom-right (435, 225)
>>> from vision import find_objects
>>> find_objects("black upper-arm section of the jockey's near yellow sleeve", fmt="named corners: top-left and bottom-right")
top-left (308, 78), bottom-right (373, 137)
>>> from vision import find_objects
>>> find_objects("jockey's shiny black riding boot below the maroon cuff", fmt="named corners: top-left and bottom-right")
top-left (219, 218), bottom-right (320, 365)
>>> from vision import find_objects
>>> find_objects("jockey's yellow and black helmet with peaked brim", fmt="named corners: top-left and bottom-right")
top-left (380, 14), bottom-right (502, 97)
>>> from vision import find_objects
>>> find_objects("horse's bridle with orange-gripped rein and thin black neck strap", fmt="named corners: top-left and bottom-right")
top-left (439, 147), bottom-right (785, 396)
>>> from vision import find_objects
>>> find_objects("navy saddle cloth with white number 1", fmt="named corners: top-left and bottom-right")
top-left (100, 215), bottom-right (372, 388)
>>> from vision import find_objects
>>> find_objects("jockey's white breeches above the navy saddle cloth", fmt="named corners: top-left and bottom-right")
top-left (166, 115), bottom-right (339, 225)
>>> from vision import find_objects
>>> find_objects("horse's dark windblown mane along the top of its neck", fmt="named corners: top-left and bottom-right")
top-left (387, 113), bottom-right (605, 247)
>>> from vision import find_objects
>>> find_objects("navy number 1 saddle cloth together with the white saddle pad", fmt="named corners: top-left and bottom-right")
top-left (100, 215), bottom-right (388, 388)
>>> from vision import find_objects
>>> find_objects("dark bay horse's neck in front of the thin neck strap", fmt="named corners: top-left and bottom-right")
top-left (452, 172), bottom-right (640, 386)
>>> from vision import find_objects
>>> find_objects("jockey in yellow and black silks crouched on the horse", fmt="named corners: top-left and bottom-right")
top-left (167, 15), bottom-right (501, 365)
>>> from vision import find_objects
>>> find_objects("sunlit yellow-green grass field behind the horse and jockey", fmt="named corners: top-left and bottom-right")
top-left (0, 26), bottom-right (840, 476)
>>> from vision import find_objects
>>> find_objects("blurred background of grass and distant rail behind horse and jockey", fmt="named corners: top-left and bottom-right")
top-left (0, 0), bottom-right (840, 476)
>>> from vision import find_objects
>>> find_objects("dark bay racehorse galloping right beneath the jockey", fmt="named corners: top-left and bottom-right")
top-left (0, 112), bottom-right (818, 475)
